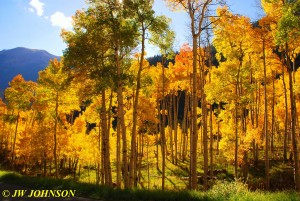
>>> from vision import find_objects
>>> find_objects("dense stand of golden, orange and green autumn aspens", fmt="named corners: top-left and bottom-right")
top-left (0, 0), bottom-right (300, 190)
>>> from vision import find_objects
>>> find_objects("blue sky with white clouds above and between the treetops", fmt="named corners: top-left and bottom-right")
top-left (0, 0), bottom-right (261, 56)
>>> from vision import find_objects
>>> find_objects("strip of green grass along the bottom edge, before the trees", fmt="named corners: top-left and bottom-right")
top-left (0, 171), bottom-right (300, 201)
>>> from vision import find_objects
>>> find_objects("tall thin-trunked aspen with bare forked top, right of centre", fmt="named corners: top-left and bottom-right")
top-left (166, 0), bottom-right (222, 189)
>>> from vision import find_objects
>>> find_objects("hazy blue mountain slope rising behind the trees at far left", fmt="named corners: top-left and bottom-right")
top-left (0, 47), bottom-right (60, 96)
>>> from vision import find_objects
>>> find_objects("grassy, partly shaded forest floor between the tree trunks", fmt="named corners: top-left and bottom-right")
top-left (74, 146), bottom-right (295, 191)
